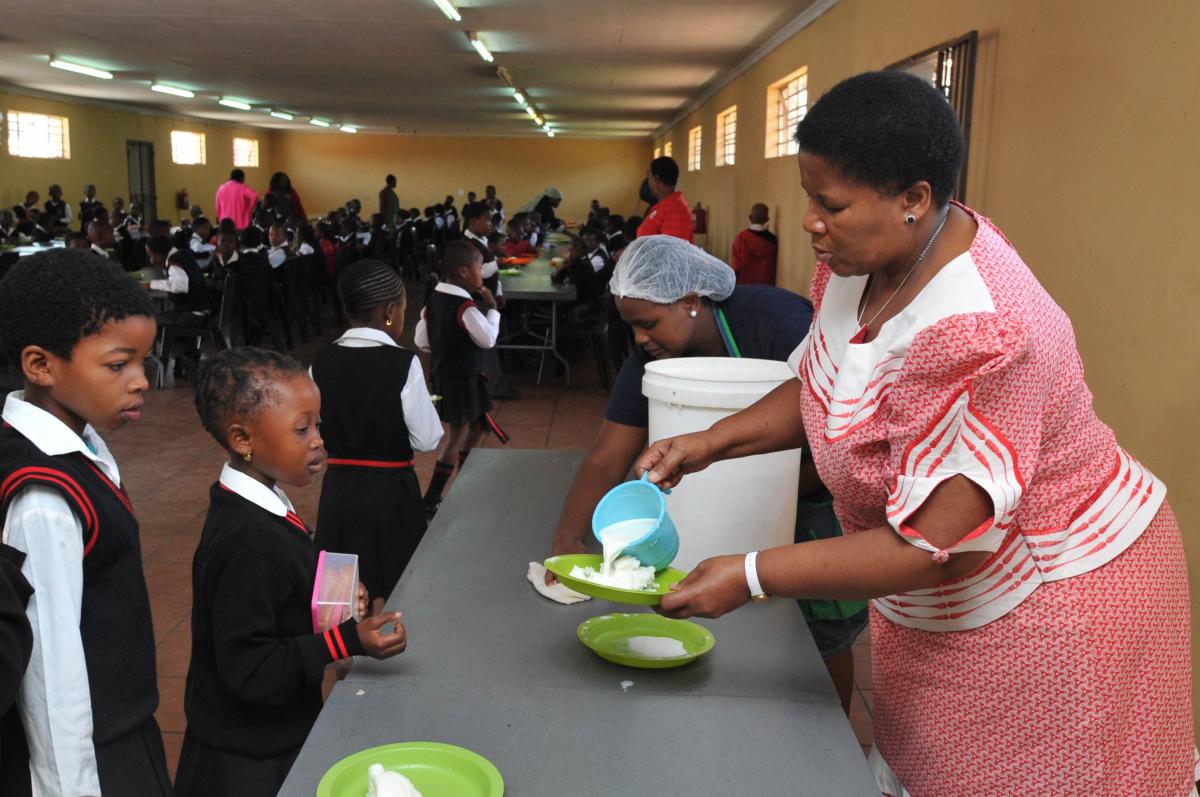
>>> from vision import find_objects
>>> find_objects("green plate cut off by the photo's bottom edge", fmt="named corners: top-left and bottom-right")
top-left (317, 742), bottom-right (504, 797)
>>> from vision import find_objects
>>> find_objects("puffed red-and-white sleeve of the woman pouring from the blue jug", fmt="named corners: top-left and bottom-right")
top-left (886, 313), bottom-right (1049, 561)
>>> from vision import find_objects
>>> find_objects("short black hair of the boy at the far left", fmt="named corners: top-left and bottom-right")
top-left (0, 247), bottom-right (155, 364)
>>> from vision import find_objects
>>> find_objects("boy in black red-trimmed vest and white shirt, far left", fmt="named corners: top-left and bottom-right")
top-left (0, 248), bottom-right (172, 797)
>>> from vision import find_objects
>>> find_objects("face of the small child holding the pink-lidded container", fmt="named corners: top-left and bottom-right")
top-left (240, 373), bottom-right (325, 487)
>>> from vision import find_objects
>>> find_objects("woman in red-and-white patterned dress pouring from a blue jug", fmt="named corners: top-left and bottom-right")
top-left (638, 72), bottom-right (1198, 797)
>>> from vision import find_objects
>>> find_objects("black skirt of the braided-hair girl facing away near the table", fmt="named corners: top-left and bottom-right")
top-left (314, 465), bottom-right (425, 600)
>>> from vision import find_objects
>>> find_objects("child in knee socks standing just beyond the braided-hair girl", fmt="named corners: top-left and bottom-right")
top-left (413, 240), bottom-right (506, 515)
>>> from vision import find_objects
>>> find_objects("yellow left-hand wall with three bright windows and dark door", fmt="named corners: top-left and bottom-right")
top-left (0, 91), bottom-right (274, 220)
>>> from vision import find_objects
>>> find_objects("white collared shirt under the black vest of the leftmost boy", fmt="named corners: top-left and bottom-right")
top-left (4, 390), bottom-right (114, 797)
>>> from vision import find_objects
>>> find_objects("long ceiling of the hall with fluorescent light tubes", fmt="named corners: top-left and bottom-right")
top-left (0, 0), bottom-right (815, 137)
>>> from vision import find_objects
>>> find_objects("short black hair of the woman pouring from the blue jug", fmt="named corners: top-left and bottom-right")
top-left (796, 70), bottom-right (966, 208)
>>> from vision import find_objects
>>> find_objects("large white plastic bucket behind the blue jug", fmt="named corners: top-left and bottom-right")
top-left (642, 356), bottom-right (800, 570)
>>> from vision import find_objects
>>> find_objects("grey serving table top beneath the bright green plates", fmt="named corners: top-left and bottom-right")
top-left (280, 450), bottom-right (878, 797)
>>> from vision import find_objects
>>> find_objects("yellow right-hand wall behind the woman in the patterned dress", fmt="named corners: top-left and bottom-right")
top-left (655, 0), bottom-right (1200, 729)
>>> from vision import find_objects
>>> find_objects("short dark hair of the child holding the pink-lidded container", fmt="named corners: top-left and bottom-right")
top-left (192, 348), bottom-right (307, 449)
